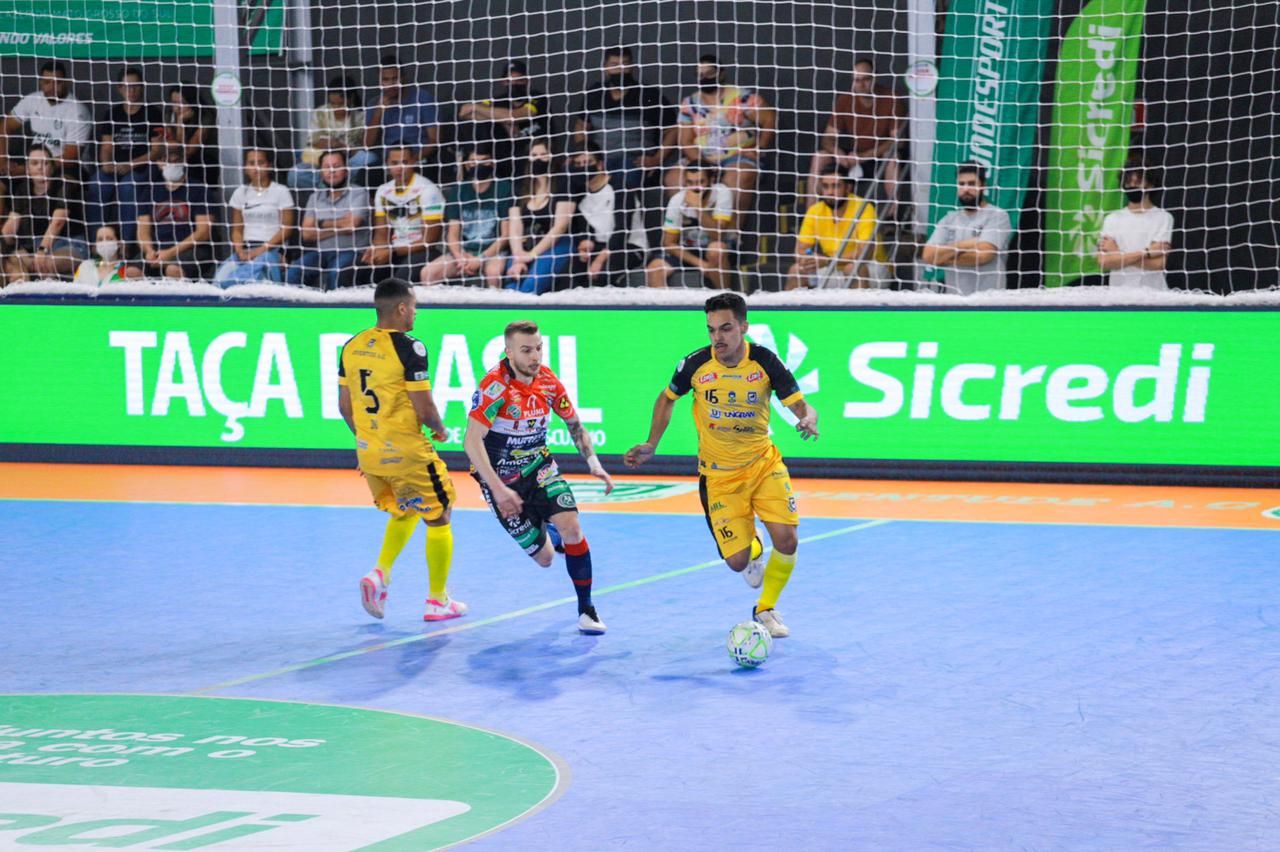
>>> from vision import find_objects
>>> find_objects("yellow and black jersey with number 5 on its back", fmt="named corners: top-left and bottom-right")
top-left (338, 327), bottom-right (435, 469)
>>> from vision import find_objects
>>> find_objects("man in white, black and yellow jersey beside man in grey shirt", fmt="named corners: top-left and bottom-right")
top-left (360, 145), bottom-right (444, 281)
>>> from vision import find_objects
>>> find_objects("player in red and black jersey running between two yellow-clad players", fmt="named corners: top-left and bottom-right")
top-left (463, 322), bottom-right (613, 635)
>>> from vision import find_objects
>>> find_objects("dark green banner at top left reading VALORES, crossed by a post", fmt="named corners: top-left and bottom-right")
top-left (0, 0), bottom-right (284, 59)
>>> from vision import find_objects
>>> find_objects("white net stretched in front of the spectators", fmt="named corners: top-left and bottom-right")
top-left (0, 0), bottom-right (1280, 294)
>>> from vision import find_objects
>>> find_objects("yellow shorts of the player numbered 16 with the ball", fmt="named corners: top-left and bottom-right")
top-left (698, 448), bottom-right (800, 559)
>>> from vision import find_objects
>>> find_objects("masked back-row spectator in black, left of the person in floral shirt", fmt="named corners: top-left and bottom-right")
top-left (573, 47), bottom-right (680, 249)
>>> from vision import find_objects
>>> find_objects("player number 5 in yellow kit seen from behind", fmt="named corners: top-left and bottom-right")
top-left (338, 278), bottom-right (467, 622)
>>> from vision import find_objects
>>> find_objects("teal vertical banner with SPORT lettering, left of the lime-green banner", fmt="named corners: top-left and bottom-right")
top-left (929, 0), bottom-right (1053, 228)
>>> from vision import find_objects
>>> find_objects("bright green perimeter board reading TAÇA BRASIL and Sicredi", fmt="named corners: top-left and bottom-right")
top-left (0, 304), bottom-right (1280, 466)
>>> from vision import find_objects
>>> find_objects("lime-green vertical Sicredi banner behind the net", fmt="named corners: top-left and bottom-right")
top-left (1044, 0), bottom-right (1147, 287)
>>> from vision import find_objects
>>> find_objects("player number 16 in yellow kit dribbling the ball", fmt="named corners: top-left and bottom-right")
top-left (623, 293), bottom-right (818, 629)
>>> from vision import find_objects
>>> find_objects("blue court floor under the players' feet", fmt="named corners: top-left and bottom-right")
top-left (0, 501), bottom-right (1280, 849)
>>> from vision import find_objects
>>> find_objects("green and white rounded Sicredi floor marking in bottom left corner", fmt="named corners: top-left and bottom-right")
top-left (0, 695), bottom-right (568, 852)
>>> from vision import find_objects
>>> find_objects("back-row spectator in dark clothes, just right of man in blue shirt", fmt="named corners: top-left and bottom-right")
top-left (458, 59), bottom-right (550, 179)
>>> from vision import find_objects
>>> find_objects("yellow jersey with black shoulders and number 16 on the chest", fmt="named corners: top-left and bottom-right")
top-left (666, 343), bottom-right (804, 476)
